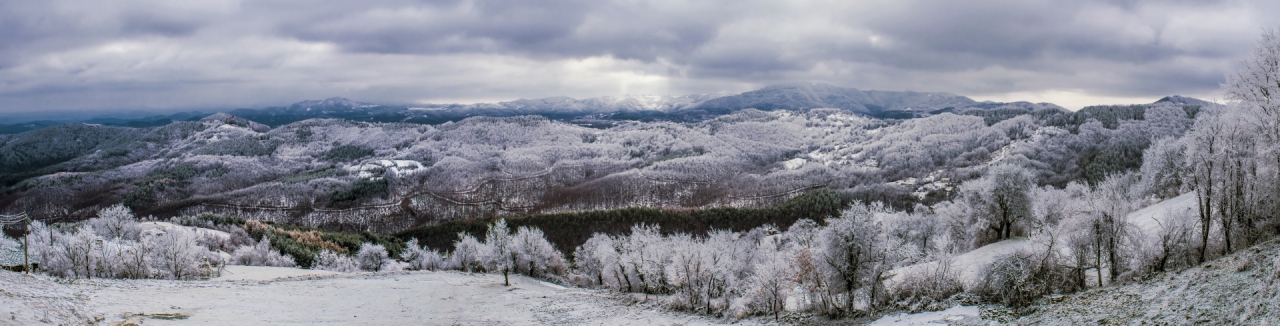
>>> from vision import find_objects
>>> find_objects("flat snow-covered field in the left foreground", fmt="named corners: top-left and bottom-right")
top-left (0, 266), bottom-right (772, 325)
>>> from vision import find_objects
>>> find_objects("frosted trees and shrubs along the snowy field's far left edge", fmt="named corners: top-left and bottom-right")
top-left (13, 205), bottom-right (430, 280)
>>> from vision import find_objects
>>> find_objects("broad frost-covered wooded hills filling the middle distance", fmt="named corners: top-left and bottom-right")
top-left (0, 100), bottom-right (1198, 233)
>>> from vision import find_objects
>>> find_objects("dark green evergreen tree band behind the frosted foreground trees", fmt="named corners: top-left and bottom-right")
top-left (396, 189), bottom-right (851, 252)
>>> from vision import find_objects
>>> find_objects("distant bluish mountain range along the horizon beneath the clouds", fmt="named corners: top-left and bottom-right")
top-left (0, 83), bottom-right (1208, 134)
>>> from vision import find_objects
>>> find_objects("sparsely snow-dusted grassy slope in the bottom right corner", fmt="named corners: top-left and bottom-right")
top-left (1016, 240), bottom-right (1280, 325)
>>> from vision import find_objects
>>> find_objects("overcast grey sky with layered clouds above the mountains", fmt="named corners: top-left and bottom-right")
top-left (0, 0), bottom-right (1280, 114)
